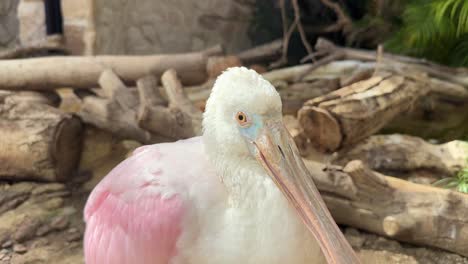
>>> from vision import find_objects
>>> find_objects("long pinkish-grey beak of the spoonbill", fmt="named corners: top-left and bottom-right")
top-left (253, 121), bottom-right (359, 264)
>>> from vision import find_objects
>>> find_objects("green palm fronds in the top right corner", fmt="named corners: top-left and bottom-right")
top-left (386, 0), bottom-right (468, 66)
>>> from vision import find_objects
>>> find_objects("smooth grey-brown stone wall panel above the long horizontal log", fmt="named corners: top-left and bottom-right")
top-left (89, 0), bottom-right (255, 54)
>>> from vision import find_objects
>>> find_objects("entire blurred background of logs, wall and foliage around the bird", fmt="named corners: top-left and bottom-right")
top-left (0, 0), bottom-right (468, 263)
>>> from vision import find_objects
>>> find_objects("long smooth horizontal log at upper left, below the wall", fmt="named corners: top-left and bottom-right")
top-left (0, 45), bottom-right (221, 90)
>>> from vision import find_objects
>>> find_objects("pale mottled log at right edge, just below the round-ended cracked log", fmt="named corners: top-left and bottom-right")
top-left (334, 135), bottom-right (468, 179)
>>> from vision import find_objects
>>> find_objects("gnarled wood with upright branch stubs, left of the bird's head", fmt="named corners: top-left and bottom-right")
top-left (79, 69), bottom-right (201, 144)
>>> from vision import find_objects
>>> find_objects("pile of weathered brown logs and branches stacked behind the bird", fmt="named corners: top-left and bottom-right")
top-left (0, 40), bottom-right (468, 256)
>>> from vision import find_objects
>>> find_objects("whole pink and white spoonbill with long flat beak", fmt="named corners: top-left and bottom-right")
top-left (84, 67), bottom-right (359, 264)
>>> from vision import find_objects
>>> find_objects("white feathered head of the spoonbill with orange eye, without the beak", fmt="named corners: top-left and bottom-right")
top-left (203, 67), bottom-right (282, 168)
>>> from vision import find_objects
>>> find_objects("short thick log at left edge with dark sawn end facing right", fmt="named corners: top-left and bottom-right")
top-left (0, 101), bottom-right (82, 181)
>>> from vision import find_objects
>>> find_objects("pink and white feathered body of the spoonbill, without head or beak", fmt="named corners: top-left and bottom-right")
top-left (85, 137), bottom-right (324, 264)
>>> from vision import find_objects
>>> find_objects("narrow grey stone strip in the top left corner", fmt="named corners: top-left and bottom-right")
top-left (0, 0), bottom-right (19, 48)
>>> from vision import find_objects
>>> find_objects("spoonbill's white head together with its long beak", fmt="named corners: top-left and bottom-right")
top-left (203, 67), bottom-right (358, 263)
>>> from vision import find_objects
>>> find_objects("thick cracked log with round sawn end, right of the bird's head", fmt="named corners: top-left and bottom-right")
top-left (298, 74), bottom-right (428, 152)
